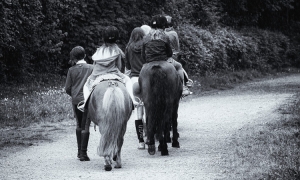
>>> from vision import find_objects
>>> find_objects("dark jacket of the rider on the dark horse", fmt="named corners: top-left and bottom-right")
top-left (142, 35), bottom-right (173, 62)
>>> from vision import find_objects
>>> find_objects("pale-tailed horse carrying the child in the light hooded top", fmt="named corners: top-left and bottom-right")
top-left (84, 80), bottom-right (133, 171)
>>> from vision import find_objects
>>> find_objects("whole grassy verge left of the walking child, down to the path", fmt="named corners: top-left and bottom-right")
top-left (0, 76), bottom-right (74, 150)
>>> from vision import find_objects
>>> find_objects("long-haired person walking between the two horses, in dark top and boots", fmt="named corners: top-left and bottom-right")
top-left (125, 27), bottom-right (150, 149)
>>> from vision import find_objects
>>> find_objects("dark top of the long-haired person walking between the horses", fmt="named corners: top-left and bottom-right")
top-left (125, 40), bottom-right (146, 77)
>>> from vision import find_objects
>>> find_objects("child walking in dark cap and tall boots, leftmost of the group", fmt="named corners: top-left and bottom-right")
top-left (65, 46), bottom-right (93, 161)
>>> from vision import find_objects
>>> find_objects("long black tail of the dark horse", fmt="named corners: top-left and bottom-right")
top-left (148, 65), bottom-right (168, 141)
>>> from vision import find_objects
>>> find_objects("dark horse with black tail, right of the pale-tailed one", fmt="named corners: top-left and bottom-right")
top-left (135, 61), bottom-right (182, 155)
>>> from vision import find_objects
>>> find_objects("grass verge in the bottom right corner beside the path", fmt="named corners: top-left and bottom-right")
top-left (223, 93), bottom-right (300, 180)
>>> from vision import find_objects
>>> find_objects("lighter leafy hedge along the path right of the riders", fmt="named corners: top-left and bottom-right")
top-left (178, 24), bottom-right (290, 75)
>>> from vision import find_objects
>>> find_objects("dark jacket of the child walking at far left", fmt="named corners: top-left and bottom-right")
top-left (65, 64), bottom-right (93, 104)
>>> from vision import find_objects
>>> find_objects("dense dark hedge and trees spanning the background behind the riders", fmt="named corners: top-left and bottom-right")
top-left (0, 0), bottom-right (300, 82)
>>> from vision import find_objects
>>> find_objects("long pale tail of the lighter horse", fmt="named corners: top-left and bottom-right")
top-left (98, 86), bottom-right (127, 157)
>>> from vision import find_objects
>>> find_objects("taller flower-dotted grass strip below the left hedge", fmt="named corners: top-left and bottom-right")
top-left (0, 76), bottom-right (72, 127)
